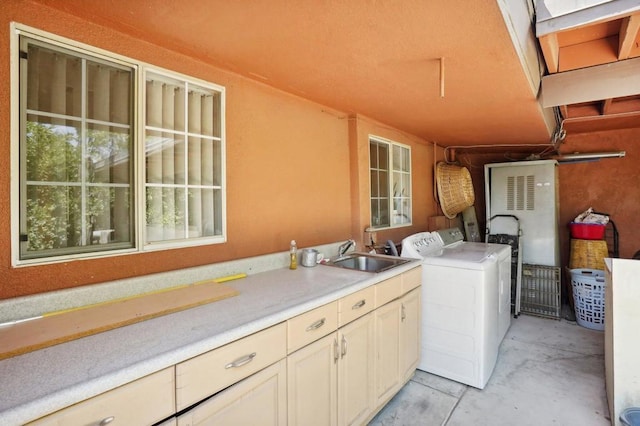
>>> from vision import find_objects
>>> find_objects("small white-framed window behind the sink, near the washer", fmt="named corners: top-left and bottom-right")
top-left (369, 136), bottom-right (412, 229)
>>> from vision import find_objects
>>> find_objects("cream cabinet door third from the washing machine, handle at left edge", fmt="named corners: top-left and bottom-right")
top-left (338, 313), bottom-right (375, 425)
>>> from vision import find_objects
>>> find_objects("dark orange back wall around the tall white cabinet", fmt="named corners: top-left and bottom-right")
top-left (459, 128), bottom-right (640, 267)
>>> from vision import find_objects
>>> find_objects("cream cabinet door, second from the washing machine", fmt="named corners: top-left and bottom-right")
top-left (375, 300), bottom-right (401, 406)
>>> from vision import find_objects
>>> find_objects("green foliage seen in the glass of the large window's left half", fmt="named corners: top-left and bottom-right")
top-left (26, 121), bottom-right (130, 252)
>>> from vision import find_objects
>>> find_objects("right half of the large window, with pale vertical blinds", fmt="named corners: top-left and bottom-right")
top-left (144, 70), bottom-right (224, 246)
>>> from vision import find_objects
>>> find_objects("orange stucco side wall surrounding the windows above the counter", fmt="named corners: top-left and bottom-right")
top-left (0, 0), bottom-right (435, 299)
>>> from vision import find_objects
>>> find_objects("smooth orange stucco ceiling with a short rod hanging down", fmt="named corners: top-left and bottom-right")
top-left (34, 0), bottom-right (638, 150)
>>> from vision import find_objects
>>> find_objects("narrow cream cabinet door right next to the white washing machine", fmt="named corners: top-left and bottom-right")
top-left (400, 288), bottom-right (422, 383)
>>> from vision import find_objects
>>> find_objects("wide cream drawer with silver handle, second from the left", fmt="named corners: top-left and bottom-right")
top-left (176, 323), bottom-right (287, 411)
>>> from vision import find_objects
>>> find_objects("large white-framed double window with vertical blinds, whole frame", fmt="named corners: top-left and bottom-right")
top-left (11, 25), bottom-right (226, 265)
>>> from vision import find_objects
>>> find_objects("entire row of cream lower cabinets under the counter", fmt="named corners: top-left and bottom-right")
top-left (28, 268), bottom-right (421, 426)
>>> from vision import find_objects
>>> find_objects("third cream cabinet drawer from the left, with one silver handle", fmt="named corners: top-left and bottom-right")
top-left (287, 301), bottom-right (338, 353)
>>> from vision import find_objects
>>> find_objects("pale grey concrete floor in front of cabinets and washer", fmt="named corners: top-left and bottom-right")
top-left (369, 314), bottom-right (610, 426)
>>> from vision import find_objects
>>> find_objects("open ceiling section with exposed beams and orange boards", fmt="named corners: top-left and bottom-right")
top-left (536, 0), bottom-right (640, 132)
